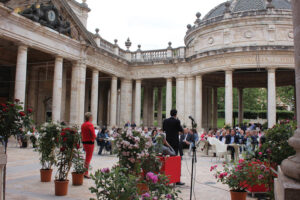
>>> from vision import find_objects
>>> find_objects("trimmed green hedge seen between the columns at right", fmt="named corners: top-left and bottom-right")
top-left (218, 110), bottom-right (295, 119)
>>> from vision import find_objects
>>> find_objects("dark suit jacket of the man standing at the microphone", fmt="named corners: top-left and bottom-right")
top-left (163, 117), bottom-right (183, 148)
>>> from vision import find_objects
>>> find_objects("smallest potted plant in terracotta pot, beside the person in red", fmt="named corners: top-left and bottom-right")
top-left (72, 144), bottom-right (87, 186)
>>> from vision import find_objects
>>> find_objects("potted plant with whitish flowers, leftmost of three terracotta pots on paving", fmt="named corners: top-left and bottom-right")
top-left (36, 123), bottom-right (61, 182)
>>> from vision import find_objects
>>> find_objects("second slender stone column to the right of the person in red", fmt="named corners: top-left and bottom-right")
top-left (109, 76), bottom-right (118, 127)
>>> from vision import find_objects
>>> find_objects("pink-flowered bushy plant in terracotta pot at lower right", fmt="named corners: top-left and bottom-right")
top-left (210, 159), bottom-right (264, 200)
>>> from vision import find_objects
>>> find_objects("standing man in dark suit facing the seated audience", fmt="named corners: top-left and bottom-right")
top-left (163, 109), bottom-right (184, 185)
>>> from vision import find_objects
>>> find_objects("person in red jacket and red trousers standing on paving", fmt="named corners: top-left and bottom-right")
top-left (81, 112), bottom-right (96, 179)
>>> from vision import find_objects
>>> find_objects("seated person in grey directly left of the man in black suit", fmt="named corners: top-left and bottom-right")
top-left (153, 133), bottom-right (176, 156)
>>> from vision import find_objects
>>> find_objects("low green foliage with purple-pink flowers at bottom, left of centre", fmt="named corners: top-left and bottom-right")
top-left (90, 166), bottom-right (139, 200)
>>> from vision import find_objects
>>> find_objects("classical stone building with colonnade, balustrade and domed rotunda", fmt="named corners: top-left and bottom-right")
top-left (0, 0), bottom-right (295, 129)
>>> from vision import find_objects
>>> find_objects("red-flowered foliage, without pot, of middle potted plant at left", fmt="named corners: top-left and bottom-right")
top-left (56, 128), bottom-right (80, 181)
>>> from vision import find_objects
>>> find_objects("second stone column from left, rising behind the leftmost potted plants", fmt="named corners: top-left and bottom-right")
top-left (52, 56), bottom-right (63, 122)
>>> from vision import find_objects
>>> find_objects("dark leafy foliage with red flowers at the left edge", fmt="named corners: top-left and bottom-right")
top-left (0, 99), bottom-right (33, 149)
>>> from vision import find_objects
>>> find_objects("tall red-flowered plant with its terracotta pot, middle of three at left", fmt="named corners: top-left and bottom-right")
top-left (54, 128), bottom-right (80, 196)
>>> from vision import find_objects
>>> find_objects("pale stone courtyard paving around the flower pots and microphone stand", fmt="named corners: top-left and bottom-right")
top-left (6, 144), bottom-right (253, 200)
